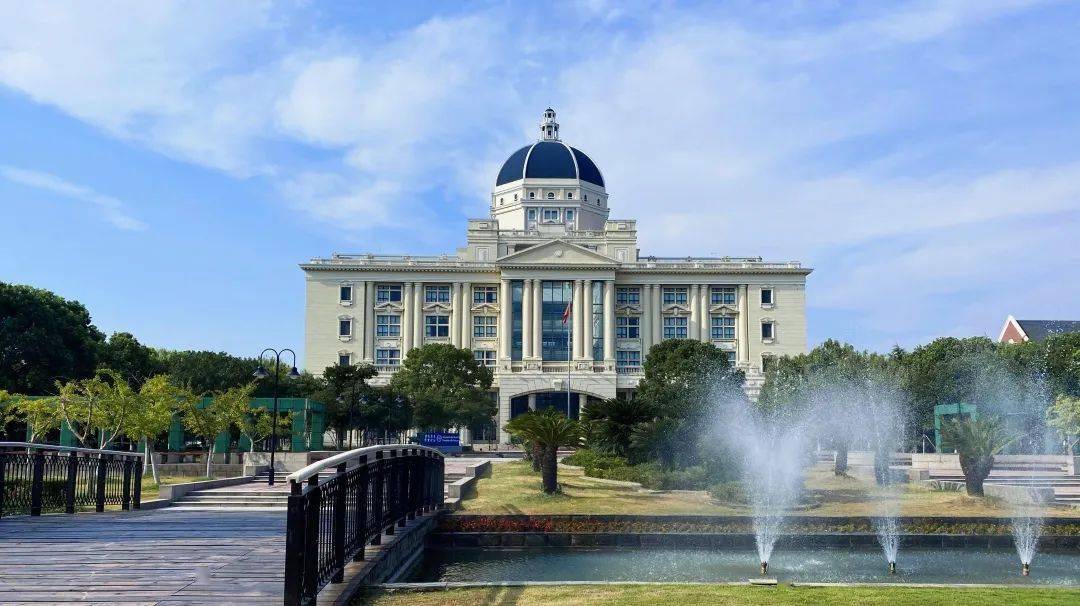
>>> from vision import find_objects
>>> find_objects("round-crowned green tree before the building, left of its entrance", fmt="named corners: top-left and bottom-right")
top-left (390, 344), bottom-right (496, 429)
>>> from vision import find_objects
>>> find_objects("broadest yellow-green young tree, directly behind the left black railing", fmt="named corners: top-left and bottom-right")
top-left (54, 369), bottom-right (140, 448)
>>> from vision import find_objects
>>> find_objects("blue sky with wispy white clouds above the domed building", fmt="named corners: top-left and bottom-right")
top-left (0, 0), bottom-right (1080, 362)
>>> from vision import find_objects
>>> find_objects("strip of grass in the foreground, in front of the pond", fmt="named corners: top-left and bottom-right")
top-left (355, 584), bottom-right (1080, 606)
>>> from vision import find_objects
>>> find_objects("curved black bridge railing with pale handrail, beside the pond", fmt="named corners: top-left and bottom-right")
top-left (285, 445), bottom-right (444, 606)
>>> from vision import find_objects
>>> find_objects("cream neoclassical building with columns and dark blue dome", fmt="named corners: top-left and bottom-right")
top-left (300, 109), bottom-right (810, 441)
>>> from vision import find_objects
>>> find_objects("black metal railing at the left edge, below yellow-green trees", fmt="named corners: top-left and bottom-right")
top-left (0, 442), bottom-right (143, 516)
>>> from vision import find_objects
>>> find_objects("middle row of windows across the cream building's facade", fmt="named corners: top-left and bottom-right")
top-left (338, 313), bottom-right (775, 340)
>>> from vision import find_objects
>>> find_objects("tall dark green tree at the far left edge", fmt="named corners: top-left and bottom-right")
top-left (0, 282), bottom-right (105, 395)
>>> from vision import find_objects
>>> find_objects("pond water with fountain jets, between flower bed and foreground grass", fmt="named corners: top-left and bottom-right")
top-left (409, 548), bottom-right (1080, 585)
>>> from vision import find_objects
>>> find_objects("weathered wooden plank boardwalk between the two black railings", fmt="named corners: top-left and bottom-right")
top-left (0, 508), bottom-right (285, 606)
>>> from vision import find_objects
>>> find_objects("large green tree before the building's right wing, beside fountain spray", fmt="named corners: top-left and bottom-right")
top-left (630, 339), bottom-right (745, 467)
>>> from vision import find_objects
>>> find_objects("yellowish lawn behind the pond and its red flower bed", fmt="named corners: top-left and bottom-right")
top-left (460, 461), bottom-right (1080, 517)
